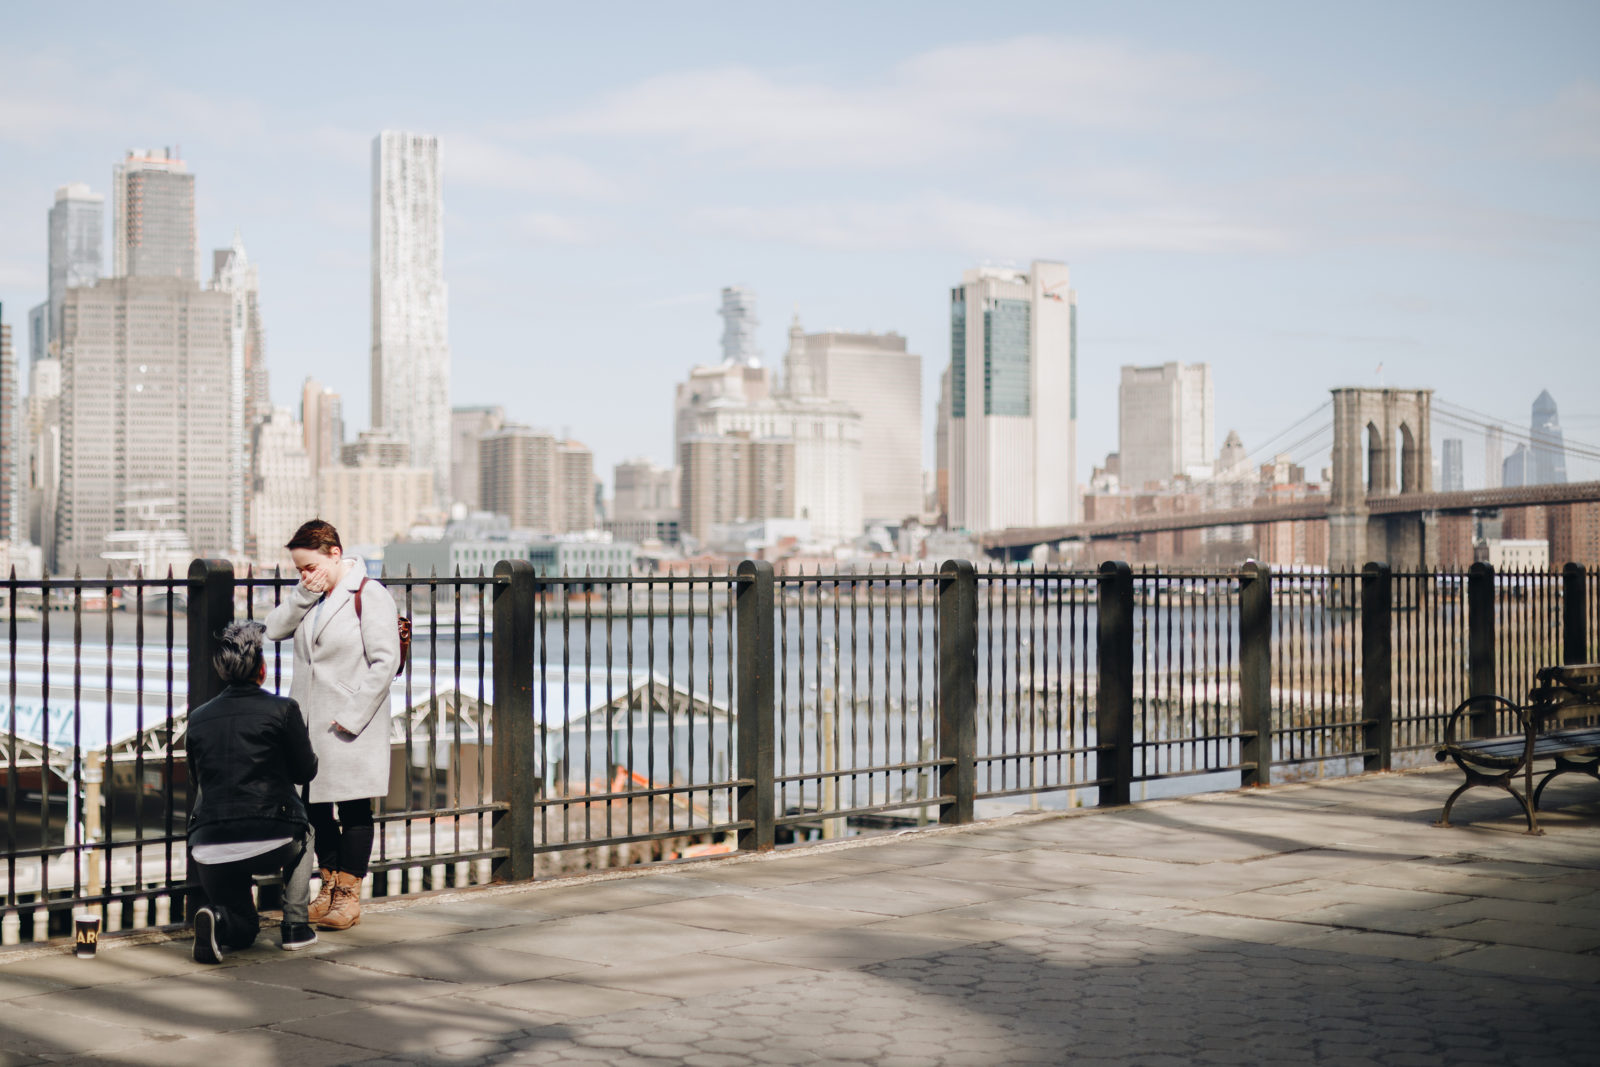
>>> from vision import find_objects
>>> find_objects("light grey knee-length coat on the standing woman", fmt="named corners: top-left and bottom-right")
top-left (267, 555), bottom-right (400, 805)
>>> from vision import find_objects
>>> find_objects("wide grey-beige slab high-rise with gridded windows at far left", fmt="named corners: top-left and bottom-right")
top-left (51, 277), bottom-right (232, 574)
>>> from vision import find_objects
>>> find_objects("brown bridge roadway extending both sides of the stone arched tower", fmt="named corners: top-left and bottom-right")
top-left (978, 482), bottom-right (1600, 552)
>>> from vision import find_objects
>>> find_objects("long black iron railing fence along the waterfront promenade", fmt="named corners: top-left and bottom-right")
top-left (0, 561), bottom-right (1600, 944)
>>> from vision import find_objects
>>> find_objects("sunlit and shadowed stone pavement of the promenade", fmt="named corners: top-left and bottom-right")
top-left (0, 773), bottom-right (1600, 1067)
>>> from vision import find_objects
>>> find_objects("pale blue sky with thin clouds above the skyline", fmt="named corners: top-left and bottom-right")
top-left (0, 0), bottom-right (1600, 488)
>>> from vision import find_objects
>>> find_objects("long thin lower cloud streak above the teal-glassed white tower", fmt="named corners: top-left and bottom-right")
top-left (690, 194), bottom-right (1290, 259)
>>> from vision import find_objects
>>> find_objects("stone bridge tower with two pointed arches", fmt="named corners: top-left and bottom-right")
top-left (1328, 389), bottom-right (1438, 571)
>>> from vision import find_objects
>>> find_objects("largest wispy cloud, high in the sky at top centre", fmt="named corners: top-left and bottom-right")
top-left (530, 37), bottom-right (1245, 168)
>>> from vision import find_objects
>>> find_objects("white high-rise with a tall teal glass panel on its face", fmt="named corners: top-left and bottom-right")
top-left (949, 262), bottom-right (1080, 533)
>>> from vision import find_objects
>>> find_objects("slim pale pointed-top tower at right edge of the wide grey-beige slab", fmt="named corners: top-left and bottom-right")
top-left (211, 232), bottom-right (272, 555)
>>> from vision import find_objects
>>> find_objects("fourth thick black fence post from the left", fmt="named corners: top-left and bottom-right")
top-left (939, 560), bottom-right (978, 825)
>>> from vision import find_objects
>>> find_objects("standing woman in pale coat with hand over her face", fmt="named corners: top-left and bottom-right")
top-left (267, 518), bottom-right (400, 929)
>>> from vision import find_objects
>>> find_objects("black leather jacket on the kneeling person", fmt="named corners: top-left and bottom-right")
top-left (187, 685), bottom-right (317, 845)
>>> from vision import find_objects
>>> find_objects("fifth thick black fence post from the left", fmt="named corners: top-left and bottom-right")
top-left (1094, 560), bottom-right (1133, 806)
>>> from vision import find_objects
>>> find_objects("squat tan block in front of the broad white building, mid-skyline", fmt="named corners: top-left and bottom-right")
top-left (678, 430), bottom-right (795, 541)
